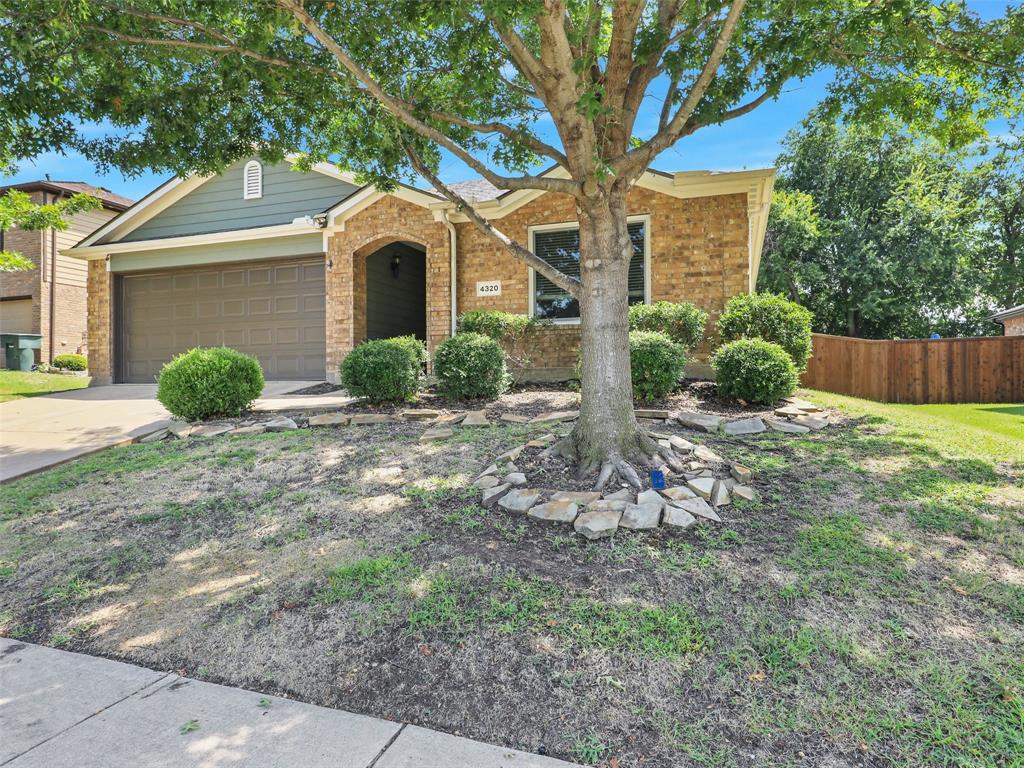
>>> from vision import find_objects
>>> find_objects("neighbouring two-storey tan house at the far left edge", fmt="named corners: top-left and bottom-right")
top-left (0, 185), bottom-right (132, 362)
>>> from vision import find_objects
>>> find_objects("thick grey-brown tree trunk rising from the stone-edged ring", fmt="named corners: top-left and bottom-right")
top-left (570, 190), bottom-right (652, 486)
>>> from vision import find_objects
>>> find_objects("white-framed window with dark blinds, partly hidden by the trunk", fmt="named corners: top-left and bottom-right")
top-left (530, 220), bottom-right (647, 321)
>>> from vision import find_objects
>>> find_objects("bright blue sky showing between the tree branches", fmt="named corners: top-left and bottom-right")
top-left (0, 0), bottom-right (1006, 200)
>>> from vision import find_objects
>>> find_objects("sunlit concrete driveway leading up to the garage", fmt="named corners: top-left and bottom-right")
top-left (0, 381), bottom-right (347, 482)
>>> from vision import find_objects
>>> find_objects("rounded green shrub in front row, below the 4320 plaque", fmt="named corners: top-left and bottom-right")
top-left (434, 333), bottom-right (510, 399)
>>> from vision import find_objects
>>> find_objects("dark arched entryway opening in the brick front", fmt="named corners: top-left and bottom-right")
top-left (365, 241), bottom-right (427, 341)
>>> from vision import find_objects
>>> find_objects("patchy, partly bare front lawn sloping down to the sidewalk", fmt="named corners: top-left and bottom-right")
top-left (0, 392), bottom-right (1024, 768)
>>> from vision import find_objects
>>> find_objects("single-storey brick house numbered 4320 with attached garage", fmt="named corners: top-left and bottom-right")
top-left (73, 160), bottom-right (774, 382)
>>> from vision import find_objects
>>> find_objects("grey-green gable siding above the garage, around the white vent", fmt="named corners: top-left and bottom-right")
top-left (121, 160), bottom-right (358, 242)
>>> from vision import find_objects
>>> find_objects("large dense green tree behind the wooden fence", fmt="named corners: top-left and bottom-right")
top-left (759, 114), bottom-right (989, 338)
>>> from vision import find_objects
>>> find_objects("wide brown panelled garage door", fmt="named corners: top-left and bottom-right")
top-left (120, 257), bottom-right (326, 382)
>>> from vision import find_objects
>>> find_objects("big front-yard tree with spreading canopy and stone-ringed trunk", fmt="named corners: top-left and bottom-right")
top-left (0, 0), bottom-right (1024, 485)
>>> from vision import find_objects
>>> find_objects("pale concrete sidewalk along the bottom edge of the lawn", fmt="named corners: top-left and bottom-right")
top-left (0, 638), bottom-right (579, 768)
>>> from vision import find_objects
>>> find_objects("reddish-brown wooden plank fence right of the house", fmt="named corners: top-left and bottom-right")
top-left (801, 334), bottom-right (1024, 402)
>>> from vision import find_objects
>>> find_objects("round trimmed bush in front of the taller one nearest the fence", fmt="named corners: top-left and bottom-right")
top-left (711, 339), bottom-right (800, 404)
